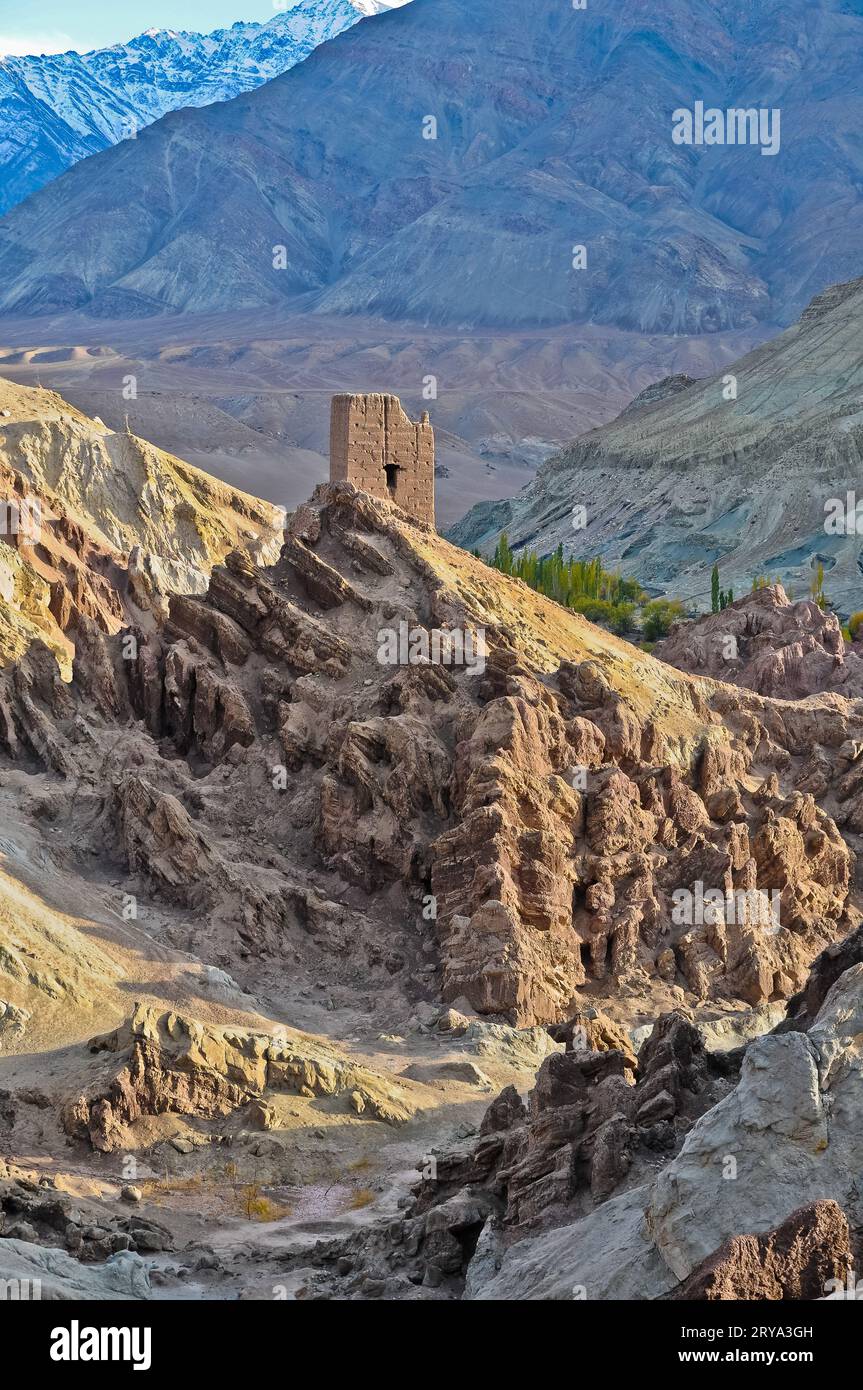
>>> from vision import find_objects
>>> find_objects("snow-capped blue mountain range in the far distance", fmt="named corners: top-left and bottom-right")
top-left (0, 0), bottom-right (404, 214)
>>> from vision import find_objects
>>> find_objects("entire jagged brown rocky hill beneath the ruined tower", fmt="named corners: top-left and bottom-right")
top-left (0, 484), bottom-right (863, 1026)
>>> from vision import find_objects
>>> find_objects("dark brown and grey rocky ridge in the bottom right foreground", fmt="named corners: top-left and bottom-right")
top-left (316, 965), bottom-right (863, 1301)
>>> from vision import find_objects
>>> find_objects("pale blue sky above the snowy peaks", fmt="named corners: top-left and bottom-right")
top-left (0, 0), bottom-right (290, 53)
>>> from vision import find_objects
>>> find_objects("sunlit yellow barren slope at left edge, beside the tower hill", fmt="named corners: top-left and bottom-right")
top-left (0, 381), bottom-right (282, 669)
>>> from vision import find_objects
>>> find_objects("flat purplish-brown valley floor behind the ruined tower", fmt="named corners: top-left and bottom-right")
top-left (0, 313), bottom-right (771, 530)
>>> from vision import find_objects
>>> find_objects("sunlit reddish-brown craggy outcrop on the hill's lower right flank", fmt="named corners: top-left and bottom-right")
top-left (432, 639), bottom-right (852, 1023)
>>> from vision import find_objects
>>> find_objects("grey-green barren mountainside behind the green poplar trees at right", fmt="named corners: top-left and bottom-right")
top-left (450, 279), bottom-right (863, 614)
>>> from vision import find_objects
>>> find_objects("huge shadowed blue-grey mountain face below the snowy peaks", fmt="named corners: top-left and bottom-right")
top-left (0, 0), bottom-right (863, 334)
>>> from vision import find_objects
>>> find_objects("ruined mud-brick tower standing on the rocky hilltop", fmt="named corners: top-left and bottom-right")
top-left (329, 395), bottom-right (435, 525)
